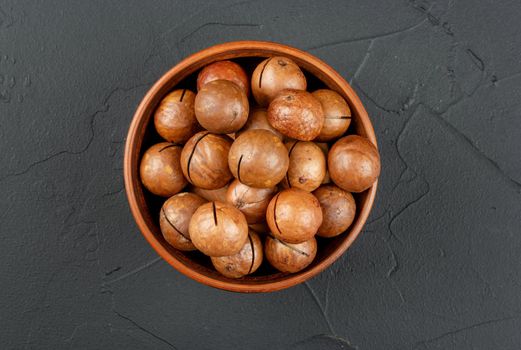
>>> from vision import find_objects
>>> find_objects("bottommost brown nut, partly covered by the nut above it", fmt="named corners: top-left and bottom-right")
top-left (211, 231), bottom-right (264, 278)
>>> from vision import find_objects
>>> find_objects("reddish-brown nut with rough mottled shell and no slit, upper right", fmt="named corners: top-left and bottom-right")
top-left (268, 90), bottom-right (324, 141)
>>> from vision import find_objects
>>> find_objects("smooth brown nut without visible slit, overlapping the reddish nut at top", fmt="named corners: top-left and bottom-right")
top-left (195, 80), bottom-right (249, 134)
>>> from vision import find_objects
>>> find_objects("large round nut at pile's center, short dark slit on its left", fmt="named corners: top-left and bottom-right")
top-left (228, 129), bottom-right (289, 188)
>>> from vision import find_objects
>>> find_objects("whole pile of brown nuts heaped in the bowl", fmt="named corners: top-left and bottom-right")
top-left (140, 57), bottom-right (380, 278)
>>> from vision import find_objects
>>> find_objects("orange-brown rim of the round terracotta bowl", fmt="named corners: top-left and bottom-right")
top-left (123, 40), bottom-right (378, 293)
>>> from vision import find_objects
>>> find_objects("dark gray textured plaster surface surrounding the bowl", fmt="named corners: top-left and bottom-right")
top-left (0, 0), bottom-right (521, 350)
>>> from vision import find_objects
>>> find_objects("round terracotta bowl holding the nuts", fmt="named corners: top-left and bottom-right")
top-left (124, 41), bottom-right (377, 293)
